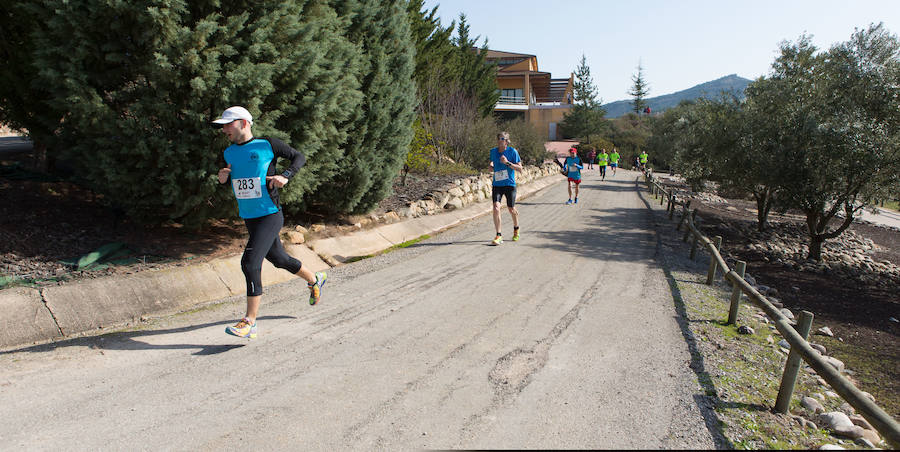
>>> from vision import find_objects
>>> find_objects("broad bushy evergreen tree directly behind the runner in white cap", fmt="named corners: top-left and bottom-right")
top-left (21, 0), bottom-right (361, 225)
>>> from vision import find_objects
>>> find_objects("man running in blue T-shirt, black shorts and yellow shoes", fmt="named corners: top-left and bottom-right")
top-left (491, 132), bottom-right (524, 246)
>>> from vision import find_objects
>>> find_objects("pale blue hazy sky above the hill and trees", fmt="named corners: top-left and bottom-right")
top-left (425, 0), bottom-right (900, 103)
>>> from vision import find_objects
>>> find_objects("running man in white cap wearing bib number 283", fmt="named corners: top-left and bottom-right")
top-left (213, 107), bottom-right (328, 339)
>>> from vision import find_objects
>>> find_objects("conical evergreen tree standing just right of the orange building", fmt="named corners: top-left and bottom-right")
top-left (560, 55), bottom-right (607, 143)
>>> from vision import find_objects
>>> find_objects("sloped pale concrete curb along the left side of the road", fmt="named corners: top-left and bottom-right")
top-left (0, 170), bottom-right (565, 349)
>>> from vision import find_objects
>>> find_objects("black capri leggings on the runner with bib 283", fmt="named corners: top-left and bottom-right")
top-left (241, 210), bottom-right (302, 297)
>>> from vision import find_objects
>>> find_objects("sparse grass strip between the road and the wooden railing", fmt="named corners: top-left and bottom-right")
top-left (670, 271), bottom-right (861, 450)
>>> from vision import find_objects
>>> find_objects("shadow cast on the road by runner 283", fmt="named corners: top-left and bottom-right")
top-left (0, 315), bottom-right (296, 356)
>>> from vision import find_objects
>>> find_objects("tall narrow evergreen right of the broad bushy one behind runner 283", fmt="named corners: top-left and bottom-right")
top-left (314, 0), bottom-right (416, 213)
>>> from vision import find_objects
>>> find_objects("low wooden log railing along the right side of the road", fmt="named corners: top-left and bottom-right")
top-left (644, 172), bottom-right (900, 448)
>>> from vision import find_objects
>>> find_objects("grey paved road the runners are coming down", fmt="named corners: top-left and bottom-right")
top-left (0, 171), bottom-right (716, 450)
